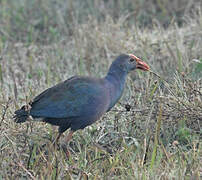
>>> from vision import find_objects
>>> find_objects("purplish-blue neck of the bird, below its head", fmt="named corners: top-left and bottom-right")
top-left (105, 69), bottom-right (127, 111)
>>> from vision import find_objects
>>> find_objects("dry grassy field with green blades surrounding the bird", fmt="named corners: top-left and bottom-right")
top-left (0, 0), bottom-right (202, 179)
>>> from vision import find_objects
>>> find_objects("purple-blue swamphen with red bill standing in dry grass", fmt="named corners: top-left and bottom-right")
top-left (14, 54), bottom-right (150, 145)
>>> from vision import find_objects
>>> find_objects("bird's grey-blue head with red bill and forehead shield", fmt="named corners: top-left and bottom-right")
top-left (111, 54), bottom-right (150, 73)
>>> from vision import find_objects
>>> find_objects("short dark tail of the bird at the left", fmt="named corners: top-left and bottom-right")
top-left (13, 106), bottom-right (29, 123)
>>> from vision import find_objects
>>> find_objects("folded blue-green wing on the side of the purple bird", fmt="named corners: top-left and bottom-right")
top-left (30, 77), bottom-right (106, 118)
